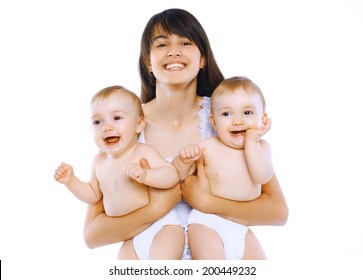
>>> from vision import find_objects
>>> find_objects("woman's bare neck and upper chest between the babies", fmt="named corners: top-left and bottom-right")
top-left (144, 82), bottom-right (202, 157)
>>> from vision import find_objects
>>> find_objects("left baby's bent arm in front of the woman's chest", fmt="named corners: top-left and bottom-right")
top-left (126, 145), bottom-right (179, 189)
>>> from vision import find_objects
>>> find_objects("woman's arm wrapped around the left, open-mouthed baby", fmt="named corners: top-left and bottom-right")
top-left (84, 184), bottom-right (180, 248)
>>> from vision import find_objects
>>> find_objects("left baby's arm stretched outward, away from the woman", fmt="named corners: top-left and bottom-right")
top-left (54, 162), bottom-right (102, 204)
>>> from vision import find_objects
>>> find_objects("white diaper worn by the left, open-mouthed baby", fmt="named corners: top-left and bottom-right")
top-left (133, 209), bottom-right (182, 260)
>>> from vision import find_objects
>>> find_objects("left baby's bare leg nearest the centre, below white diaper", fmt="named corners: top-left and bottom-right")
top-left (149, 225), bottom-right (185, 260)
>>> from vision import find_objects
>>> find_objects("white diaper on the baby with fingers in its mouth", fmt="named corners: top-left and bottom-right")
top-left (188, 209), bottom-right (248, 260)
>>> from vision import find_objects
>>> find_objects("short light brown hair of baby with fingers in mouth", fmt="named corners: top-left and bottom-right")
top-left (211, 76), bottom-right (266, 112)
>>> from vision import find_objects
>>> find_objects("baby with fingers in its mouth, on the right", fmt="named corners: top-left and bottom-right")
top-left (173, 77), bottom-right (274, 259)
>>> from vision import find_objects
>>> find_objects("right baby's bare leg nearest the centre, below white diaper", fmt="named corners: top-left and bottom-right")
top-left (188, 224), bottom-right (226, 260)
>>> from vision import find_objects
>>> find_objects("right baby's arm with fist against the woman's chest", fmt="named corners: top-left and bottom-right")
top-left (172, 144), bottom-right (205, 180)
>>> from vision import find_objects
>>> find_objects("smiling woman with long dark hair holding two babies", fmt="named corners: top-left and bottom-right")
top-left (84, 9), bottom-right (288, 259)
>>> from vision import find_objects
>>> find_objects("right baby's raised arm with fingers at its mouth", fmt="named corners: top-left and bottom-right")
top-left (245, 120), bottom-right (274, 184)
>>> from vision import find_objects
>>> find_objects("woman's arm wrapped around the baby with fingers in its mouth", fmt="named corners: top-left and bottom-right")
top-left (182, 160), bottom-right (289, 226)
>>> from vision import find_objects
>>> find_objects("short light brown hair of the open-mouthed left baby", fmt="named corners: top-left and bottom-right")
top-left (91, 85), bottom-right (144, 117)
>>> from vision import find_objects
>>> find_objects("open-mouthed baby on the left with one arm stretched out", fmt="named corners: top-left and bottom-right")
top-left (54, 86), bottom-right (185, 259)
